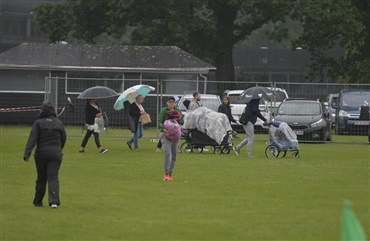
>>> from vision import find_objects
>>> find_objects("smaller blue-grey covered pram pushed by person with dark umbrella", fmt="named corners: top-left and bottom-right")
top-left (265, 121), bottom-right (299, 158)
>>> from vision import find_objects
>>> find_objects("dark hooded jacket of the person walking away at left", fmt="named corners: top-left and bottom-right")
top-left (23, 102), bottom-right (67, 160)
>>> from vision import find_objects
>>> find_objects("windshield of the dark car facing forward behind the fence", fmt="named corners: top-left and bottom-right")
top-left (278, 102), bottom-right (321, 115)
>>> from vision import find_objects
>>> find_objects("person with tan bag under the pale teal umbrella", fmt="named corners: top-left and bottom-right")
top-left (127, 95), bottom-right (145, 150)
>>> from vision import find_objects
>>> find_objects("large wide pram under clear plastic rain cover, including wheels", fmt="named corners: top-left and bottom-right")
top-left (180, 107), bottom-right (233, 154)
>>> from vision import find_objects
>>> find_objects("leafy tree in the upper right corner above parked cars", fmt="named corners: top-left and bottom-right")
top-left (292, 0), bottom-right (370, 83)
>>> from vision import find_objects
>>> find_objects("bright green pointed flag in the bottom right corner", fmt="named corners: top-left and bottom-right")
top-left (342, 200), bottom-right (367, 241)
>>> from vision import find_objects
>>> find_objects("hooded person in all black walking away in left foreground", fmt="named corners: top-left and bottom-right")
top-left (23, 102), bottom-right (67, 208)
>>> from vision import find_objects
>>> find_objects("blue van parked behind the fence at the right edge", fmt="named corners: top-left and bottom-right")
top-left (335, 89), bottom-right (370, 135)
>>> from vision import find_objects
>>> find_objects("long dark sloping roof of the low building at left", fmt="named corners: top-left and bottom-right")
top-left (0, 43), bottom-right (216, 73)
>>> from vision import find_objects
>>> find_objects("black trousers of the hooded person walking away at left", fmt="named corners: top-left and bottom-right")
top-left (33, 148), bottom-right (62, 206)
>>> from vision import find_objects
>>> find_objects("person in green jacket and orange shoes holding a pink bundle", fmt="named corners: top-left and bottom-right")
top-left (158, 96), bottom-right (184, 181)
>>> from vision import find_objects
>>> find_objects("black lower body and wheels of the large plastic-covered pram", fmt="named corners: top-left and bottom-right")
top-left (180, 129), bottom-right (233, 154)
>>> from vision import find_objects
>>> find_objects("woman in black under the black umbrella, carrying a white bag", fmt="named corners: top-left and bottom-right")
top-left (79, 99), bottom-right (108, 154)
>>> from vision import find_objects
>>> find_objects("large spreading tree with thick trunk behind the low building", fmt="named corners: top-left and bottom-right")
top-left (35, 0), bottom-right (292, 80)
